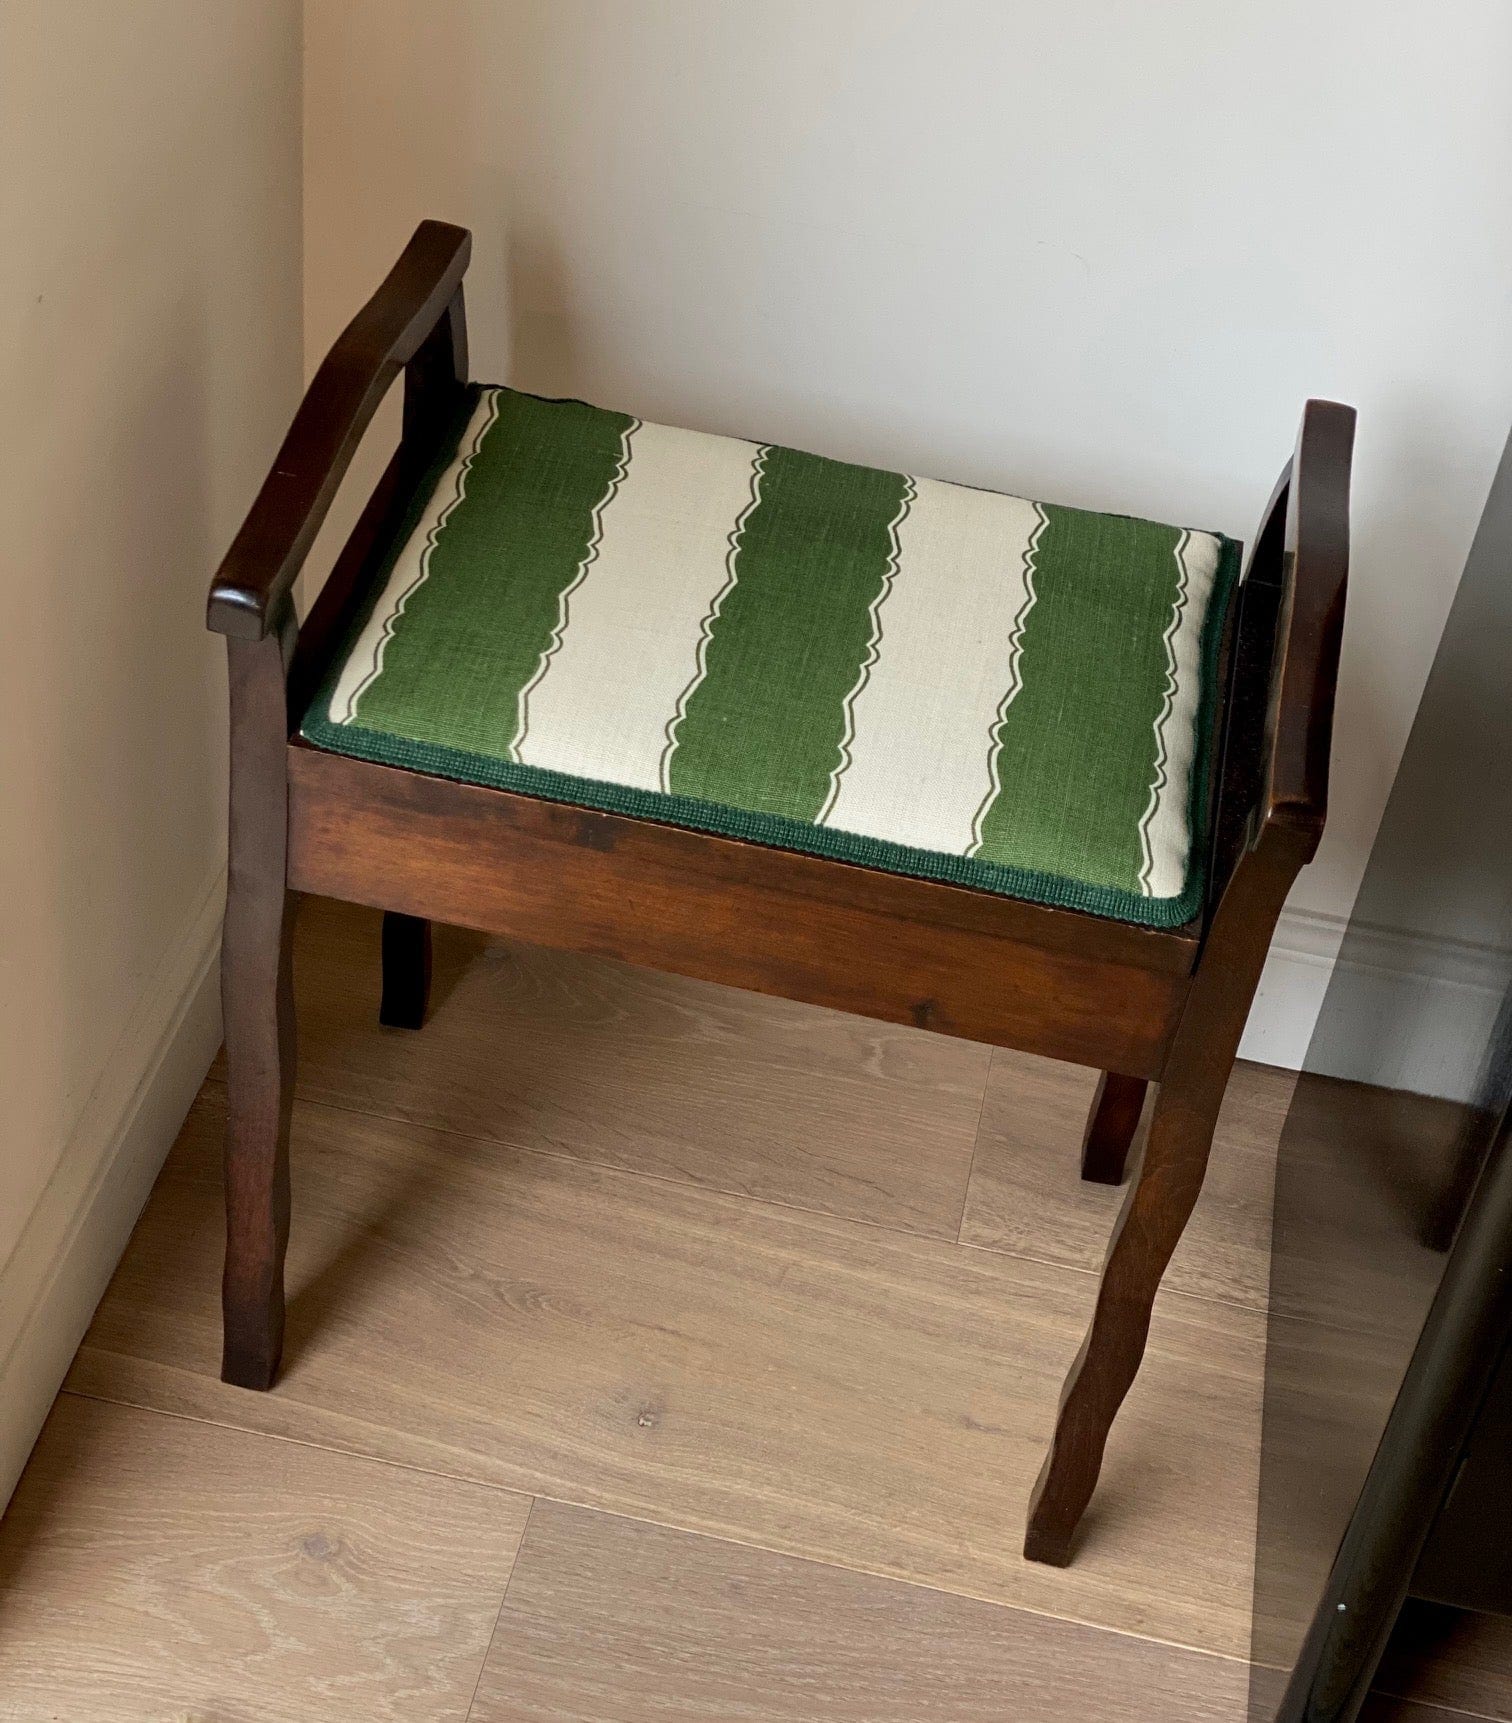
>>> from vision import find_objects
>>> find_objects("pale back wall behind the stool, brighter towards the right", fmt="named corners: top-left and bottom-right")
top-left (305, 0), bottom-right (1512, 1056)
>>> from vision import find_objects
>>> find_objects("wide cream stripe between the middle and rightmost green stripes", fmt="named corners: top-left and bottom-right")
top-left (823, 479), bottom-right (1044, 855)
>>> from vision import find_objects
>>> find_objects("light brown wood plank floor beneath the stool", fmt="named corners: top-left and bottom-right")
top-left (0, 903), bottom-right (1512, 1723)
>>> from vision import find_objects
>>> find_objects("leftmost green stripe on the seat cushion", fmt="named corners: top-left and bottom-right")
top-left (356, 389), bottom-right (635, 768)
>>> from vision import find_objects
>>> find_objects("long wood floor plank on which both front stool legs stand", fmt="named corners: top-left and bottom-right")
top-left (71, 1089), bottom-right (1264, 1656)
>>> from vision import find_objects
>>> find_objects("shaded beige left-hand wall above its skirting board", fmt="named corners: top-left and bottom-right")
top-left (0, 0), bottom-right (301, 1502)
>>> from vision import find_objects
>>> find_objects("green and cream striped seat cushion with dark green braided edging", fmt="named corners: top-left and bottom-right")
top-left (303, 388), bottom-right (1236, 925)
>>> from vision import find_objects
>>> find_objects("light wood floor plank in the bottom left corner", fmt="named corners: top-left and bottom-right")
top-left (0, 1394), bottom-right (529, 1723)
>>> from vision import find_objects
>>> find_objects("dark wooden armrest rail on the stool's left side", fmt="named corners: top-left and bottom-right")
top-left (205, 221), bottom-right (472, 639)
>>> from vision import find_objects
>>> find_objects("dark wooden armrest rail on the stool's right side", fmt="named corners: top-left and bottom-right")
top-left (1264, 401), bottom-right (1355, 846)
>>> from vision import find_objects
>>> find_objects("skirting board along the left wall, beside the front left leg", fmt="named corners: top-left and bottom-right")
top-left (0, 875), bottom-right (226, 1504)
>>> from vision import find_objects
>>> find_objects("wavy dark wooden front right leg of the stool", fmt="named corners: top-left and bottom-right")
top-left (1023, 1073), bottom-right (1226, 1568)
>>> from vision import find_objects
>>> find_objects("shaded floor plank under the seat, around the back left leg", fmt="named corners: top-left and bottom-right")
top-left (217, 899), bottom-right (991, 1239)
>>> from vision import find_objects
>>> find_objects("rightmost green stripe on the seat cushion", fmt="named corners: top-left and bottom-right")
top-left (975, 505), bottom-right (1181, 893)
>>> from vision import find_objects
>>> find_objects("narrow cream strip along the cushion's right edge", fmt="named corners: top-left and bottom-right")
top-left (1140, 532), bottom-right (1218, 898)
